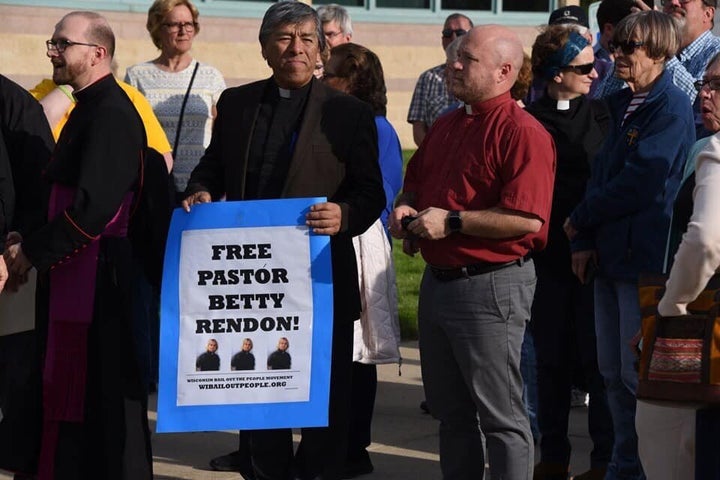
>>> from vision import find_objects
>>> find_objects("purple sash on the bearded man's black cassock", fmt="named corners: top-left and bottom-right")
top-left (38, 184), bottom-right (133, 480)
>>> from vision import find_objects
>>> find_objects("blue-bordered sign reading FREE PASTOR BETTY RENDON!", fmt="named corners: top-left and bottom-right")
top-left (157, 198), bottom-right (332, 432)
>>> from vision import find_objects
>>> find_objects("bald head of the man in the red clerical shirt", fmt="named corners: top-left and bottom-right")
top-left (452, 25), bottom-right (523, 103)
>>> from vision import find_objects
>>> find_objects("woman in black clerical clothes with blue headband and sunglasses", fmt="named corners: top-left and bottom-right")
top-left (526, 25), bottom-right (613, 480)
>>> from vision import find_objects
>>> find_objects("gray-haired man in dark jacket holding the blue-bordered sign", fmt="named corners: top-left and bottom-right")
top-left (183, 2), bottom-right (385, 480)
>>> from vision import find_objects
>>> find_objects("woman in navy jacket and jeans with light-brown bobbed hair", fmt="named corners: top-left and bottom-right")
top-left (564, 11), bottom-right (695, 479)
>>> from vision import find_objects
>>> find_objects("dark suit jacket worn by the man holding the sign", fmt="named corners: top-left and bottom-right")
top-left (186, 78), bottom-right (385, 321)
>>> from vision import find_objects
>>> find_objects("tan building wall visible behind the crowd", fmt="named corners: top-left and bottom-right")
top-left (0, 4), bottom-right (537, 148)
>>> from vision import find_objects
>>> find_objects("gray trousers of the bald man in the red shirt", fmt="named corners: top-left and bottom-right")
top-left (418, 261), bottom-right (535, 480)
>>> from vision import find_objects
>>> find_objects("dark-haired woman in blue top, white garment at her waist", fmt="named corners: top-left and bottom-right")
top-left (323, 43), bottom-right (402, 478)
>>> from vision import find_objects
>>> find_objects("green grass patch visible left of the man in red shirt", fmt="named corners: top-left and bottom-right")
top-left (393, 150), bottom-right (425, 340)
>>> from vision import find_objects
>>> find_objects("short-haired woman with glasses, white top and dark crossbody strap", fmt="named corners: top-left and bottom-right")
top-left (125, 0), bottom-right (225, 198)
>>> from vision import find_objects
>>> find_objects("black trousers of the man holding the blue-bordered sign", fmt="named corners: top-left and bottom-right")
top-left (248, 319), bottom-right (353, 480)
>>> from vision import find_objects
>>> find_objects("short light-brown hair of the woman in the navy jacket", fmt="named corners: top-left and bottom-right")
top-left (613, 10), bottom-right (680, 60)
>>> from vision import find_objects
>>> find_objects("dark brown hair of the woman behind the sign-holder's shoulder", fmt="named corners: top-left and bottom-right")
top-left (330, 43), bottom-right (387, 116)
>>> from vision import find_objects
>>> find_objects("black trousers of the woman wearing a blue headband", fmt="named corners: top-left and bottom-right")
top-left (531, 262), bottom-right (614, 468)
